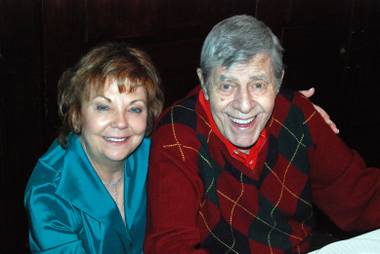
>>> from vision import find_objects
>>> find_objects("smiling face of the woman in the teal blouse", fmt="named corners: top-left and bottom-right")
top-left (80, 79), bottom-right (148, 170)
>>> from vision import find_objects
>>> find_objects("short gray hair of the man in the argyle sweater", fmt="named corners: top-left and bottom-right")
top-left (200, 15), bottom-right (283, 89)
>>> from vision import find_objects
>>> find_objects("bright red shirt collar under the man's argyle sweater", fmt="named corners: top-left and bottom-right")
top-left (198, 90), bottom-right (267, 169)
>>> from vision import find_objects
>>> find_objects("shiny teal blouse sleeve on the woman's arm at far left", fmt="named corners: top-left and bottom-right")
top-left (24, 164), bottom-right (85, 253)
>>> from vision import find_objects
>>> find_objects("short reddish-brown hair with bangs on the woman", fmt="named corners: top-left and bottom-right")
top-left (58, 43), bottom-right (164, 145)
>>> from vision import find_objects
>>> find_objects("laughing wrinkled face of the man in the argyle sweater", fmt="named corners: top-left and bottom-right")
top-left (201, 54), bottom-right (278, 152)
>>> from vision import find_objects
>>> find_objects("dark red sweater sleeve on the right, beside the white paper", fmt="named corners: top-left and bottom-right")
top-left (298, 94), bottom-right (380, 231)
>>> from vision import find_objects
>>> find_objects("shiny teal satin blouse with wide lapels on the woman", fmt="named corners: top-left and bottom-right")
top-left (24, 134), bottom-right (150, 254)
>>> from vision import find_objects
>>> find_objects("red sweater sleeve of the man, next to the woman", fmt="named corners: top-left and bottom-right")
top-left (144, 124), bottom-right (208, 254)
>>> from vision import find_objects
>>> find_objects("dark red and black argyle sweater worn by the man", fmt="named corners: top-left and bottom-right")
top-left (145, 88), bottom-right (380, 254)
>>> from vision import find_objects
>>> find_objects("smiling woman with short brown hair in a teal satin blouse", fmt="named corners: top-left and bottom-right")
top-left (25, 43), bottom-right (163, 253)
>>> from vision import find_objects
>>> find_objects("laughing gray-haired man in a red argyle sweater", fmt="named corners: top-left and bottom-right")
top-left (145, 15), bottom-right (380, 254)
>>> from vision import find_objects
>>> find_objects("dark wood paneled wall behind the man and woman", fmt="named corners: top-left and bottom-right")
top-left (0, 0), bottom-right (380, 253)
